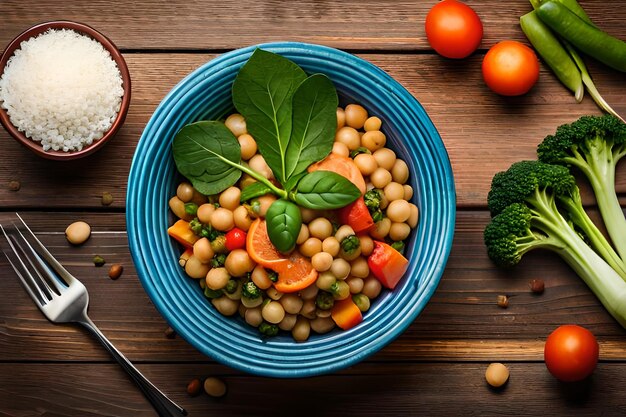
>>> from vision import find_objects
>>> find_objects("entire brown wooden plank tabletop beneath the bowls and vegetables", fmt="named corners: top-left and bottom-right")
top-left (0, 0), bottom-right (626, 416)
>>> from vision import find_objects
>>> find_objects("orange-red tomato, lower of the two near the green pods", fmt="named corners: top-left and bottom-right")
top-left (483, 41), bottom-right (539, 96)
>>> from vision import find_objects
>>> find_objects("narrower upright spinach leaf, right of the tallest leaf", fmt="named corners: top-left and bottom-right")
top-left (285, 74), bottom-right (339, 178)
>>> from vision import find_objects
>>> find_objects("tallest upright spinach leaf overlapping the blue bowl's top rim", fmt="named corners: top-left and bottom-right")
top-left (233, 49), bottom-right (306, 184)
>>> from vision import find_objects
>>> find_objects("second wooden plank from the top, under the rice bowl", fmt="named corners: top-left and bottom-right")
top-left (0, 54), bottom-right (626, 210)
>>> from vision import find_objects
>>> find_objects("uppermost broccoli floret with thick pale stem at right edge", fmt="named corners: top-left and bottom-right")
top-left (537, 115), bottom-right (626, 260)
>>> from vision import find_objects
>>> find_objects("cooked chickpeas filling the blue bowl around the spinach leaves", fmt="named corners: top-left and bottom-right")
top-left (169, 104), bottom-right (418, 341)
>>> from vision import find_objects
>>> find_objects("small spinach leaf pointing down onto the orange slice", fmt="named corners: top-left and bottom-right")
top-left (265, 199), bottom-right (302, 253)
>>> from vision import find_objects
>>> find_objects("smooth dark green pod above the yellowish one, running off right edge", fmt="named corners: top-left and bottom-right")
top-left (537, 1), bottom-right (626, 72)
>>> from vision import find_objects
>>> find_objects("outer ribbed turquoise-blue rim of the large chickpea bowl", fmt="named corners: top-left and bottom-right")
top-left (127, 42), bottom-right (456, 378)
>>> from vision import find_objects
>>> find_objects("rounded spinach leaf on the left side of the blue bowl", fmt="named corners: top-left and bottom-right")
top-left (172, 121), bottom-right (241, 195)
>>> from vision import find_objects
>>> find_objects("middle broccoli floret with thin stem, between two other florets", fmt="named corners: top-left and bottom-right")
top-left (487, 161), bottom-right (626, 278)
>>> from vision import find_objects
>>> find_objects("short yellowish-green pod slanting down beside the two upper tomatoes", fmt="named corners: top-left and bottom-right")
top-left (520, 11), bottom-right (585, 103)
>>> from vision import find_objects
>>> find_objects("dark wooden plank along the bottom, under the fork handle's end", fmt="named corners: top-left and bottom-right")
top-left (0, 362), bottom-right (626, 417)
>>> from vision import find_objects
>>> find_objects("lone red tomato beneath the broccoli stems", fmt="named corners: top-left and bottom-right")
top-left (543, 324), bottom-right (599, 382)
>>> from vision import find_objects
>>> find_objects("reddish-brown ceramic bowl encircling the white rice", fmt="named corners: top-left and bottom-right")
top-left (0, 21), bottom-right (131, 160)
